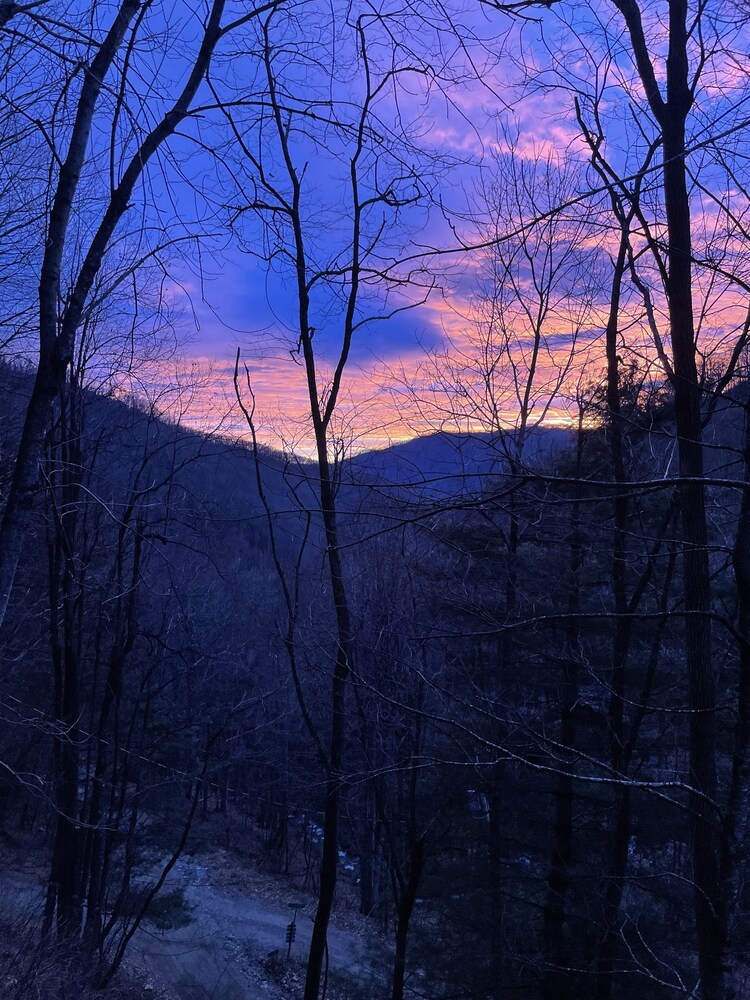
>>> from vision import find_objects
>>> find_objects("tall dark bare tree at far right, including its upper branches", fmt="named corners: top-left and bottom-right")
top-left (560, 2), bottom-right (746, 998)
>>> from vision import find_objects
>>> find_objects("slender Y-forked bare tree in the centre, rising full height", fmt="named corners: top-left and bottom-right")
top-left (226, 6), bottom-right (450, 1000)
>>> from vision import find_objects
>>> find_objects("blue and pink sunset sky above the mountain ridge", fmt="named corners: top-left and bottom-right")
top-left (33, 0), bottom-right (750, 454)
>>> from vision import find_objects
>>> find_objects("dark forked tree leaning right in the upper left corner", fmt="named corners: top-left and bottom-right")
top-left (0, 0), bottom-right (277, 620)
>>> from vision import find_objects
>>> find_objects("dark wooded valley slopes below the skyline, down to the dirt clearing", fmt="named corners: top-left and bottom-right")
top-left (2, 367), bottom-right (747, 998)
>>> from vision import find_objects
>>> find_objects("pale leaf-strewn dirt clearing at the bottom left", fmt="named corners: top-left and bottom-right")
top-left (0, 816), bottom-right (388, 1000)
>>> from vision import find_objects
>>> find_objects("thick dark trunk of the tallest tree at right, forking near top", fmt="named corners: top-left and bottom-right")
top-left (617, 2), bottom-right (726, 1000)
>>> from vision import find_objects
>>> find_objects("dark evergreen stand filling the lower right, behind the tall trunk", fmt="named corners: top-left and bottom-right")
top-left (334, 382), bottom-right (747, 998)
